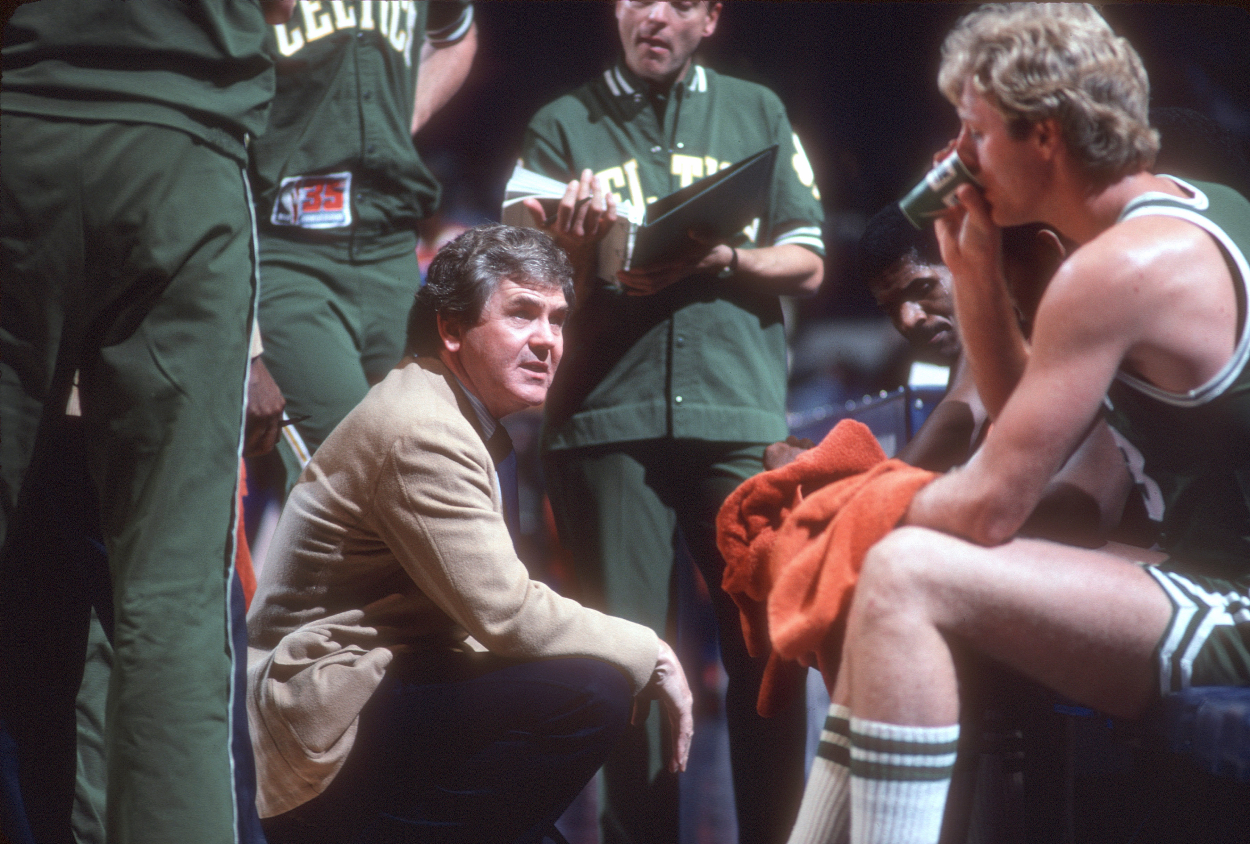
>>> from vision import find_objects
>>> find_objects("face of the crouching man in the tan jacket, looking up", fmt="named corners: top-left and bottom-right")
top-left (439, 279), bottom-right (569, 419)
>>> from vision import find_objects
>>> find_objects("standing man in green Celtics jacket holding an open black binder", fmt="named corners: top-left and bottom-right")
top-left (521, 1), bottom-right (824, 844)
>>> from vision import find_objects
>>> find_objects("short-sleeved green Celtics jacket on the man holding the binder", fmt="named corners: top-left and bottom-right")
top-left (521, 63), bottom-right (824, 448)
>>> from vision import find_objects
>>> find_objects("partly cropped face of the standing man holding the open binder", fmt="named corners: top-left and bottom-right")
top-left (616, 0), bottom-right (720, 88)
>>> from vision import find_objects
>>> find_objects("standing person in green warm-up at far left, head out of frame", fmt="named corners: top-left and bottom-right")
top-left (0, 0), bottom-right (290, 844)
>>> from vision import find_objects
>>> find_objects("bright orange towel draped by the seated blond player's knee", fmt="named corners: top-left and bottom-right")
top-left (716, 420), bottom-right (936, 716)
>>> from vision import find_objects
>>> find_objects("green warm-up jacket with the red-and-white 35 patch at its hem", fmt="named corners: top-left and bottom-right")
top-left (251, 0), bottom-right (473, 258)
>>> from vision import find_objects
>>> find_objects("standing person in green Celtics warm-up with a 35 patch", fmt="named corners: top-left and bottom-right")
top-left (250, 0), bottom-right (478, 486)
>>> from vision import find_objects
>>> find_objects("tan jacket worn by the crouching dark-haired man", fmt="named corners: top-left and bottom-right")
top-left (248, 358), bottom-right (659, 818)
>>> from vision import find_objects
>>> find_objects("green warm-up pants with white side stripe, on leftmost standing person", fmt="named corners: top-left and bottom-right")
top-left (0, 114), bottom-right (256, 844)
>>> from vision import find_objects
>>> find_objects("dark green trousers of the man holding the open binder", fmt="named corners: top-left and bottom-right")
top-left (544, 439), bottom-right (806, 844)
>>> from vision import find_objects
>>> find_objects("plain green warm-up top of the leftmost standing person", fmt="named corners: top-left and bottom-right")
top-left (0, 0), bottom-right (274, 163)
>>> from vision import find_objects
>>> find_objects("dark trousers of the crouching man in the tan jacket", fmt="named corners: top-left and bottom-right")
top-left (263, 654), bottom-right (633, 844)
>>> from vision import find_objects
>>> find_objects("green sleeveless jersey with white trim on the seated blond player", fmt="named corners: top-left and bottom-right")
top-left (1108, 180), bottom-right (1250, 579)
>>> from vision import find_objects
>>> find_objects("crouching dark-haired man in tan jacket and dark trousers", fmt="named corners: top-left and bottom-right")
top-left (248, 225), bottom-right (691, 844)
